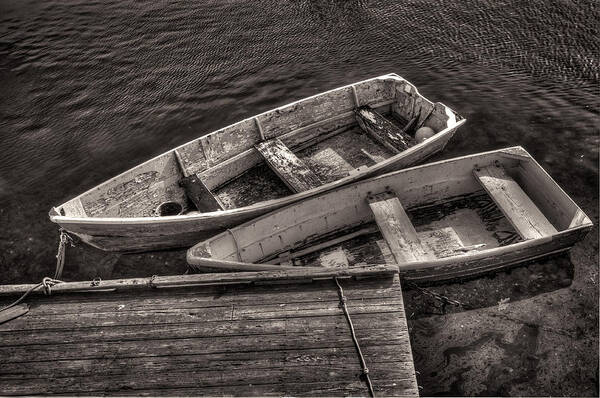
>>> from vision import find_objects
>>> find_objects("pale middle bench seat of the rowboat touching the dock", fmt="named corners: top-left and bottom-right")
top-left (367, 191), bottom-right (432, 266)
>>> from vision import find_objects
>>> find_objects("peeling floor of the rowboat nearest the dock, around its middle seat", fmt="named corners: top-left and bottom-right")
top-left (264, 192), bottom-right (521, 267)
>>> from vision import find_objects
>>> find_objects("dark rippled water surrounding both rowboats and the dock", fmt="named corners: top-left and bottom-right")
top-left (0, 0), bottom-right (600, 395)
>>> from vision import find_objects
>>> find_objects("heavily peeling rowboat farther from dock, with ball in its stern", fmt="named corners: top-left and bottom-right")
top-left (50, 74), bottom-right (465, 251)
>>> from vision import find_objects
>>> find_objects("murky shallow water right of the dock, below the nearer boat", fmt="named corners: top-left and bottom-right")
top-left (404, 222), bottom-right (598, 396)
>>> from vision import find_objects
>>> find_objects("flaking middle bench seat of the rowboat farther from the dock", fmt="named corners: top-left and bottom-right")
top-left (255, 138), bottom-right (321, 192)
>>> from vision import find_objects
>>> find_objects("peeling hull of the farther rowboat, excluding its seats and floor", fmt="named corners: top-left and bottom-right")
top-left (50, 74), bottom-right (465, 252)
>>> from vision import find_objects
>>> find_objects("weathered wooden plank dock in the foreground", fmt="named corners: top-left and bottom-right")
top-left (0, 266), bottom-right (418, 396)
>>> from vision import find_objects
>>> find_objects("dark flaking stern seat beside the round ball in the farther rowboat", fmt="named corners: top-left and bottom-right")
top-left (355, 106), bottom-right (414, 153)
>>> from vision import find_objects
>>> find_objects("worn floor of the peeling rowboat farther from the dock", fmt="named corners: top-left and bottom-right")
top-left (213, 122), bottom-right (400, 210)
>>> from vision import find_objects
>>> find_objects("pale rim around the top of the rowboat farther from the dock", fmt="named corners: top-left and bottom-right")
top-left (48, 73), bottom-right (467, 225)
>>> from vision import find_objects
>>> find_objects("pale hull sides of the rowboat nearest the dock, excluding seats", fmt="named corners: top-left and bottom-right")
top-left (187, 147), bottom-right (592, 282)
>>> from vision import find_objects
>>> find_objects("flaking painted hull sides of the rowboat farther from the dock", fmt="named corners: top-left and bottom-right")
top-left (50, 75), bottom-right (465, 252)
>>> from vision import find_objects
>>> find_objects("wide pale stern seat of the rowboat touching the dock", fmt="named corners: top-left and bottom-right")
top-left (473, 166), bottom-right (557, 239)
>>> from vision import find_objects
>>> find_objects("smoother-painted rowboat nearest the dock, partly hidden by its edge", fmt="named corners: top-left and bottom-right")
top-left (187, 147), bottom-right (592, 282)
